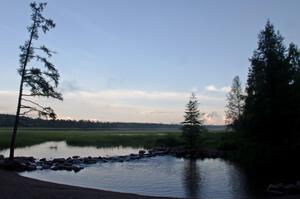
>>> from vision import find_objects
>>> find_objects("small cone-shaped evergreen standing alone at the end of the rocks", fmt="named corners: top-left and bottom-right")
top-left (182, 93), bottom-right (205, 148)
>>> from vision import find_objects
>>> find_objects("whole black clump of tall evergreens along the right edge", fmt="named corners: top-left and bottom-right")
top-left (228, 21), bottom-right (300, 168)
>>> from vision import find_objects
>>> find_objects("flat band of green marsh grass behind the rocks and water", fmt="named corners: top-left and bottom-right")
top-left (0, 128), bottom-right (236, 150)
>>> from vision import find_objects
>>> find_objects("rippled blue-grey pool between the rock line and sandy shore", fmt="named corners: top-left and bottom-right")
top-left (21, 156), bottom-right (253, 199)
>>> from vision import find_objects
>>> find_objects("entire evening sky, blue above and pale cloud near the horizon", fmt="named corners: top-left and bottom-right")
top-left (0, 0), bottom-right (300, 124)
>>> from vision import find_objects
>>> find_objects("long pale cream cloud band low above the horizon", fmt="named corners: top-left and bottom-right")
top-left (0, 89), bottom-right (224, 124)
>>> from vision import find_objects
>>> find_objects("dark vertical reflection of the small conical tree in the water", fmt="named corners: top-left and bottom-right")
top-left (183, 160), bottom-right (201, 198)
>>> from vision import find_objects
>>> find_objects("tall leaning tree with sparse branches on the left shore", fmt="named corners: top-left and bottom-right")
top-left (10, 2), bottom-right (63, 159)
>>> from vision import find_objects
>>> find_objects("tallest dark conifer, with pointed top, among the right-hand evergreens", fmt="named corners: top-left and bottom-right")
top-left (243, 21), bottom-right (293, 145)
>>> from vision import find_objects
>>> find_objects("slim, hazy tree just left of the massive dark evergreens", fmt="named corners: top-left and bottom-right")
top-left (225, 76), bottom-right (244, 130)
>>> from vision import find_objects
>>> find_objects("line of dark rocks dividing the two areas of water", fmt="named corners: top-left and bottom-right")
top-left (0, 148), bottom-right (223, 172)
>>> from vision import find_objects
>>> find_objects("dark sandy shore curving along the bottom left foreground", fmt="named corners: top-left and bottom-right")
top-left (0, 170), bottom-right (300, 199)
